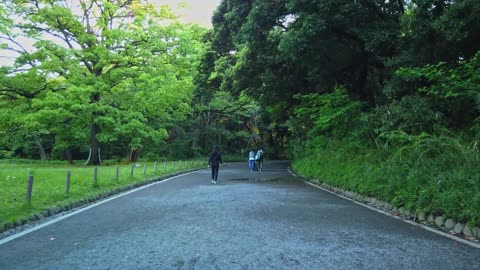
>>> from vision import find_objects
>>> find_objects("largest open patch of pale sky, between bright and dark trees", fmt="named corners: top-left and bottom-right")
top-left (149, 0), bottom-right (221, 27)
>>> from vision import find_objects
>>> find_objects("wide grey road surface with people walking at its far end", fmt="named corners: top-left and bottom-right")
top-left (0, 162), bottom-right (480, 270)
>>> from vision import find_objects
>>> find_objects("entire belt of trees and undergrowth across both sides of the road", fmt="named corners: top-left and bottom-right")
top-left (0, 0), bottom-right (480, 224)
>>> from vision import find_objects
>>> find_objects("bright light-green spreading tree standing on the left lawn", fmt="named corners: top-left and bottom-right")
top-left (1, 0), bottom-right (203, 164)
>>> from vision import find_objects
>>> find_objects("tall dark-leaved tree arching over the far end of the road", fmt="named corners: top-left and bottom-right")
top-left (194, 0), bottom-right (405, 154)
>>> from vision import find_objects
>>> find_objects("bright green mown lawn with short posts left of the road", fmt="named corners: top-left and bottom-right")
top-left (0, 161), bottom-right (206, 226)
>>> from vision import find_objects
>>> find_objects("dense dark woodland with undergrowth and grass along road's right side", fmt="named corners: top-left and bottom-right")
top-left (193, 0), bottom-right (480, 225)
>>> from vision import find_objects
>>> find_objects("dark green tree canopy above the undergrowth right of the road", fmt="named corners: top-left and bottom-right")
top-left (197, 0), bottom-right (480, 150)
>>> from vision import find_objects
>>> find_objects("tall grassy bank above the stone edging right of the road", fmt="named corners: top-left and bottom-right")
top-left (292, 136), bottom-right (480, 225)
